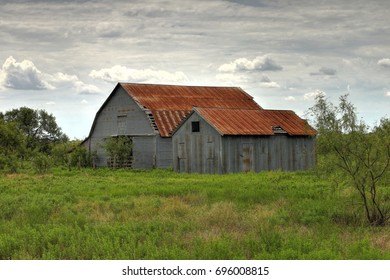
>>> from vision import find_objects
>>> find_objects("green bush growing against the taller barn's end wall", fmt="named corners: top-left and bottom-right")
top-left (102, 136), bottom-right (133, 168)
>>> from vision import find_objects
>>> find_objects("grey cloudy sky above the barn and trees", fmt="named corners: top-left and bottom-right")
top-left (0, 0), bottom-right (390, 139)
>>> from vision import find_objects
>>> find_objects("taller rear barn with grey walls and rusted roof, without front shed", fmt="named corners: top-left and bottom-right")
top-left (83, 83), bottom-right (261, 169)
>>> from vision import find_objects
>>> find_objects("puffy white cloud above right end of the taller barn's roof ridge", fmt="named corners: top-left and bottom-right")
top-left (218, 55), bottom-right (283, 73)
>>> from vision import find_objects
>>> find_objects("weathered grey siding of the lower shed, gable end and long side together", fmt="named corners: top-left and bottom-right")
top-left (173, 113), bottom-right (315, 173)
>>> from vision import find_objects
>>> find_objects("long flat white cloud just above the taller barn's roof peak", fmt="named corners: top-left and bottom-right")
top-left (89, 65), bottom-right (188, 83)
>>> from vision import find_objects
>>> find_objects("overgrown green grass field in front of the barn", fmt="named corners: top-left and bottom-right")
top-left (0, 169), bottom-right (390, 259)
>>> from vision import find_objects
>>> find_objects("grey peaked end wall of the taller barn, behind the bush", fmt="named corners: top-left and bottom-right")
top-left (85, 87), bottom-right (156, 168)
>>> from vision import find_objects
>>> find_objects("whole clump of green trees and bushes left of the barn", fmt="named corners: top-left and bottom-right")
top-left (0, 107), bottom-right (90, 173)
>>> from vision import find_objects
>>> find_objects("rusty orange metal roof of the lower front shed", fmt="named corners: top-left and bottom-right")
top-left (194, 108), bottom-right (316, 136)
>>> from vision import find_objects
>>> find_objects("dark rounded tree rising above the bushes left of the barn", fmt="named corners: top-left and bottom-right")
top-left (3, 107), bottom-right (68, 153)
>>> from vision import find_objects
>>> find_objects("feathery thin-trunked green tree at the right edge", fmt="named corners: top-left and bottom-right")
top-left (309, 94), bottom-right (390, 226)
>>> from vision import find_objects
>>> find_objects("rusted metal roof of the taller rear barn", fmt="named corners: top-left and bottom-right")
top-left (120, 83), bottom-right (262, 137)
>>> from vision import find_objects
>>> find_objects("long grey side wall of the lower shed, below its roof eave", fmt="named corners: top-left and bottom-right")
top-left (222, 135), bottom-right (315, 173)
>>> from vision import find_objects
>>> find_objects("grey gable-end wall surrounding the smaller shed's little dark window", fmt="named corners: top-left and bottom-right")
top-left (172, 113), bottom-right (221, 174)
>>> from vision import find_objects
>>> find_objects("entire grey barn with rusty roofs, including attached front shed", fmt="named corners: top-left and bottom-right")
top-left (82, 83), bottom-right (315, 173)
